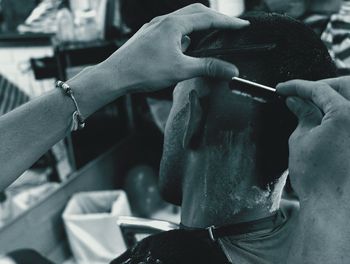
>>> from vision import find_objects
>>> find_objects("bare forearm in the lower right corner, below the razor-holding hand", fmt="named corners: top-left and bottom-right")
top-left (287, 197), bottom-right (350, 264)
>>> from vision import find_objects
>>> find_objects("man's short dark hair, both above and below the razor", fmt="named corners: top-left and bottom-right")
top-left (186, 12), bottom-right (336, 188)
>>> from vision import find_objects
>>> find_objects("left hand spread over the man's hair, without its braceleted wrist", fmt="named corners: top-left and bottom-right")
top-left (99, 4), bottom-right (249, 92)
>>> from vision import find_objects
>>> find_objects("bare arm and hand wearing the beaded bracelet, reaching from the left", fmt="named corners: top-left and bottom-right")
top-left (0, 4), bottom-right (249, 191)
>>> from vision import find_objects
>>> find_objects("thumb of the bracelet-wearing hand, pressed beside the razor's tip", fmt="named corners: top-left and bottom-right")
top-left (184, 57), bottom-right (239, 80)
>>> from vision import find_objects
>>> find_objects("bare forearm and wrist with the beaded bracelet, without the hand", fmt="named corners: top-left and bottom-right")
top-left (0, 64), bottom-right (124, 190)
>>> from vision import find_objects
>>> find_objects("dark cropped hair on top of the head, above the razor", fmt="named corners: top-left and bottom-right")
top-left (195, 12), bottom-right (336, 86)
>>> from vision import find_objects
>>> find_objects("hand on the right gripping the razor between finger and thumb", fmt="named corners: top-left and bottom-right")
top-left (277, 77), bottom-right (350, 204)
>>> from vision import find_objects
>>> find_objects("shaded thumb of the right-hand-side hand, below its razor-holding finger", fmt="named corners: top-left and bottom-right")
top-left (286, 96), bottom-right (322, 129)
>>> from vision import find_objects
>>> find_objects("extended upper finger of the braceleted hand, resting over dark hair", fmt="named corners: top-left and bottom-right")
top-left (178, 11), bottom-right (250, 35)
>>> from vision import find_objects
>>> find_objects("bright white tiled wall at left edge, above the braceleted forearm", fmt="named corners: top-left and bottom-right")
top-left (0, 46), bottom-right (54, 97)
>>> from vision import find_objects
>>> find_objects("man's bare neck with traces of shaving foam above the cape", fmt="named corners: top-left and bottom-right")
top-left (181, 131), bottom-right (273, 227)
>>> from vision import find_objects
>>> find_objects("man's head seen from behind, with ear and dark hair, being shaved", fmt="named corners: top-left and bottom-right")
top-left (160, 14), bottom-right (335, 204)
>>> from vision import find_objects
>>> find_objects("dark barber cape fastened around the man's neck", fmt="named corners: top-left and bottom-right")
top-left (111, 200), bottom-right (299, 264)
